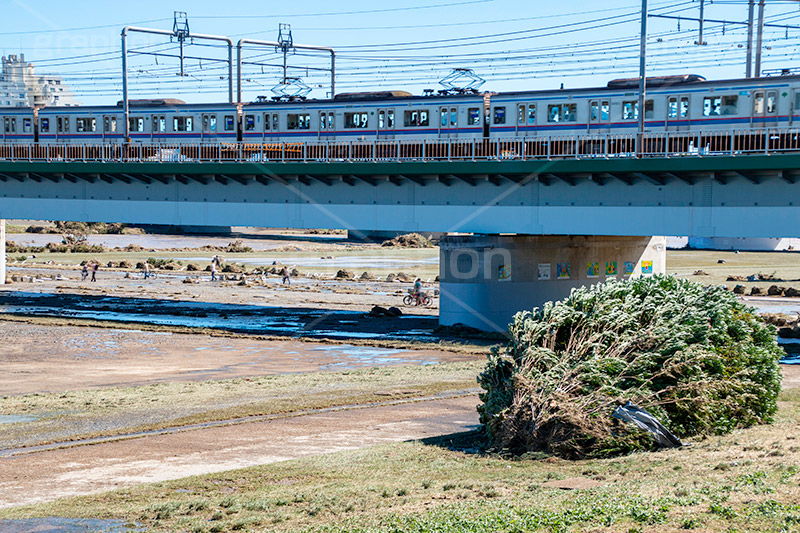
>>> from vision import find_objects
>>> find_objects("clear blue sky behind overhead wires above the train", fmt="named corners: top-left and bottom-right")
top-left (0, 0), bottom-right (800, 104)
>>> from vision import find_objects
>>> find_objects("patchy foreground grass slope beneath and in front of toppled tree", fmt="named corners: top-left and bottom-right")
top-left (0, 389), bottom-right (800, 532)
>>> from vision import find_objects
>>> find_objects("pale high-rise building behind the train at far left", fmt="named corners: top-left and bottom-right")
top-left (0, 54), bottom-right (80, 107)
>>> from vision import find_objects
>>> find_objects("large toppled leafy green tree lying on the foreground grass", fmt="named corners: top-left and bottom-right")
top-left (478, 276), bottom-right (783, 458)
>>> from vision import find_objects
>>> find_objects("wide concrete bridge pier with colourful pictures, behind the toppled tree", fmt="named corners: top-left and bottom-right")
top-left (439, 235), bottom-right (667, 332)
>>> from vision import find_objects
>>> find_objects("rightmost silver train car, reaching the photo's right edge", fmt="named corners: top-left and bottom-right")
top-left (487, 75), bottom-right (800, 138)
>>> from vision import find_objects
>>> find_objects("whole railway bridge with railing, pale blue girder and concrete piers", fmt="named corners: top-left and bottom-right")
top-left (0, 130), bottom-right (800, 330)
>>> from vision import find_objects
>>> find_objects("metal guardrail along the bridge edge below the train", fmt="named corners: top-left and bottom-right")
top-left (0, 128), bottom-right (800, 163)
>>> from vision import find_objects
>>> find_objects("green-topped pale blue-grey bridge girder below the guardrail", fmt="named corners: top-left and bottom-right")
top-left (0, 155), bottom-right (800, 237)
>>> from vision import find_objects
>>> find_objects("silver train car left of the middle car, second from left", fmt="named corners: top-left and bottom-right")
top-left (38, 99), bottom-right (238, 144)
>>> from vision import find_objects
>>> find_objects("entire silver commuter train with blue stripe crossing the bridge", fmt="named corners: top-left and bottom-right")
top-left (0, 75), bottom-right (800, 144)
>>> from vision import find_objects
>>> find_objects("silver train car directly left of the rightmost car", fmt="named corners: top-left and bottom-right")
top-left (241, 91), bottom-right (485, 142)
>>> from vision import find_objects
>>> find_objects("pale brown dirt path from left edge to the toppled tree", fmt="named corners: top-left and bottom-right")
top-left (0, 396), bottom-right (478, 508)
